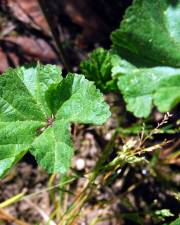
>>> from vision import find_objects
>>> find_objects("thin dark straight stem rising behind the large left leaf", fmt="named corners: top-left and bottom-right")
top-left (38, 0), bottom-right (72, 72)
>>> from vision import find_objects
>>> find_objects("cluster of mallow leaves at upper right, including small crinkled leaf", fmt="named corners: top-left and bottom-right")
top-left (80, 0), bottom-right (180, 117)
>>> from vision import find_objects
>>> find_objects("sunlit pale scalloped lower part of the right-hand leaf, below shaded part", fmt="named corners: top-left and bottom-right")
top-left (114, 61), bottom-right (180, 117)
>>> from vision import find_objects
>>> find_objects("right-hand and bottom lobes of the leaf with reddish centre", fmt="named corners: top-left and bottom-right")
top-left (31, 74), bottom-right (110, 173)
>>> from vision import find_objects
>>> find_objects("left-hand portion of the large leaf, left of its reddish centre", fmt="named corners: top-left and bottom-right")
top-left (0, 65), bottom-right (62, 177)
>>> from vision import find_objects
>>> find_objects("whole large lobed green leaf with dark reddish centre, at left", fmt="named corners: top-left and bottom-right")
top-left (0, 64), bottom-right (110, 177)
